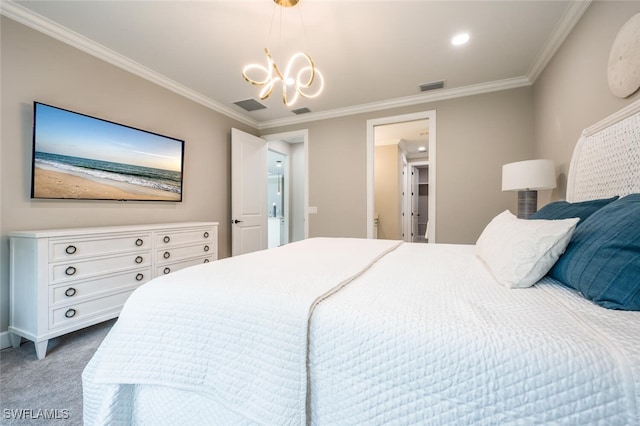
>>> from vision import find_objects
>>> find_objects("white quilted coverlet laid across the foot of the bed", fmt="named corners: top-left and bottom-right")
top-left (83, 238), bottom-right (399, 425)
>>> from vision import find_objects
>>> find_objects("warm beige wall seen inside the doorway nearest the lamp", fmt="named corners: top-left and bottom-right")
top-left (374, 144), bottom-right (402, 240)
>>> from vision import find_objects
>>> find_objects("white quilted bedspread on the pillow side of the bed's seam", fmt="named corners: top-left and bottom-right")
top-left (309, 244), bottom-right (640, 425)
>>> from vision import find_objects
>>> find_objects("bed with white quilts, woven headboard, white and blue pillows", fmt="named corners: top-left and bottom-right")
top-left (83, 101), bottom-right (640, 425)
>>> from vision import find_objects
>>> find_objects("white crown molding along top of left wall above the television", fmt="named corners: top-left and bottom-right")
top-left (0, 0), bottom-right (258, 127)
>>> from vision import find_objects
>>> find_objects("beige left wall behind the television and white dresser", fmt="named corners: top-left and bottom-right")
top-left (0, 17), bottom-right (256, 331)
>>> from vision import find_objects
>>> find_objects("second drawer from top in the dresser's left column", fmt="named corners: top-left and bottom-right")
top-left (49, 251), bottom-right (151, 285)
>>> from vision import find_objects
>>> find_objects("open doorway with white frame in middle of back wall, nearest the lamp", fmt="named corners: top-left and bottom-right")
top-left (367, 111), bottom-right (436, 242)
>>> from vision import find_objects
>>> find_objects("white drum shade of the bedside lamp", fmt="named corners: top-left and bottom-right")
top-left (502, 160), bottom-right (556, 191)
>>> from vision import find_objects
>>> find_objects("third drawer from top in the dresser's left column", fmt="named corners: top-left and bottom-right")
top-left (49, 268), bottom-right (151, 307)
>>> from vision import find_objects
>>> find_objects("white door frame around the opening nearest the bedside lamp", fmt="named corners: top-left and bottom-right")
top-left (367, 110), bottom-right (437, 242)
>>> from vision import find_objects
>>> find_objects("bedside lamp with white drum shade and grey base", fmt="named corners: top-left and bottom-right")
top-left (502, 160), bottom-right (556, 219)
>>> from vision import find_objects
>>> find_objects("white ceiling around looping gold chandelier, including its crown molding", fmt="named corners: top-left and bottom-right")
top-left (0, 0), bottom-right (589, 128)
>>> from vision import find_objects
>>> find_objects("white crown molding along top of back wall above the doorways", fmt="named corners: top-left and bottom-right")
top-left (258, 76), bottom-right (531, 130)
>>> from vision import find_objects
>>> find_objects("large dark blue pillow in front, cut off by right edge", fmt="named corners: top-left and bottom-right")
top-left (549, 194), bottom-right (640, 311)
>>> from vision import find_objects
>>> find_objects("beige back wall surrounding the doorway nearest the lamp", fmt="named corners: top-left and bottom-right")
top-left (262, 87), bottom-right (533, 244)
